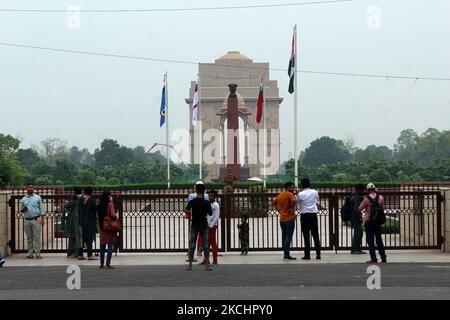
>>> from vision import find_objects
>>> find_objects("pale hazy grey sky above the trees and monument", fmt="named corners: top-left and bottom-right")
top-left (0, 0), bottom-right (450, 160)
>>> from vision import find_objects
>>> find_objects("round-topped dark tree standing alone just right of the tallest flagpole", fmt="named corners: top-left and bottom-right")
top-left (303, 137), bottom-right (350, 168)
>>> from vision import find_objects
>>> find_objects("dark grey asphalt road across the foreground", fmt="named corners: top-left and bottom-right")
top-left (0, 263), bottom-right (450, 300)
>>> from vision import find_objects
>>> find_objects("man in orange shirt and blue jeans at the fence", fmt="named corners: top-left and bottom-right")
top-left (272, 182), bottom-right (297, 261)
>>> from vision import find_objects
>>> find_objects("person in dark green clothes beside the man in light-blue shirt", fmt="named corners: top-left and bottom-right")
top-left (64, 187), bottom-right (83, 259)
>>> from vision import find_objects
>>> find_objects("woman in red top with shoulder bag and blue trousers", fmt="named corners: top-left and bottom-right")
top-left (98, 191), bottom-right (117, 269)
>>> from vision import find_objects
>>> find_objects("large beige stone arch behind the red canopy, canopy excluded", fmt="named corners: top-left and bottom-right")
top-left (186, 51), bottom-right (283, 180)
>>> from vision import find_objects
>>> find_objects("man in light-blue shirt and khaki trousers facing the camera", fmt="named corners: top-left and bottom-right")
top-left (20, 183), bottom-right (45, 259)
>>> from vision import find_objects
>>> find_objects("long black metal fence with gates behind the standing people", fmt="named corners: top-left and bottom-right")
top-left (10, 191), bottom-right (442, 253)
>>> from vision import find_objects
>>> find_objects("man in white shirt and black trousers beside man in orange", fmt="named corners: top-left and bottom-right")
top-left (297, 178), bottom-right (321, 260)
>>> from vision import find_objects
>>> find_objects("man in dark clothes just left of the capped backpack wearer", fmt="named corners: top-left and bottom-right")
top-left (346, 184), bottom-right (366, 254)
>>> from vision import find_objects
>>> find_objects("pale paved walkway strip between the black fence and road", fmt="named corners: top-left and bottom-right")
top-left (4, 250), bottom-right (450, 268)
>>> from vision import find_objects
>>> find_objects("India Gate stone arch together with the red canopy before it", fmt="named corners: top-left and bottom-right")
top-left (186, 51), bottom-right (283, 181)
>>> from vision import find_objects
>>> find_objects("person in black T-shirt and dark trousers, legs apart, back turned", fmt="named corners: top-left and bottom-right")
top-left (186, 184), bottom-right (212, 271)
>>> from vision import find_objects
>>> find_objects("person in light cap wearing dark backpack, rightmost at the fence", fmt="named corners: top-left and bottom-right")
top-left (359, 183), bottom-right (387, 264)
